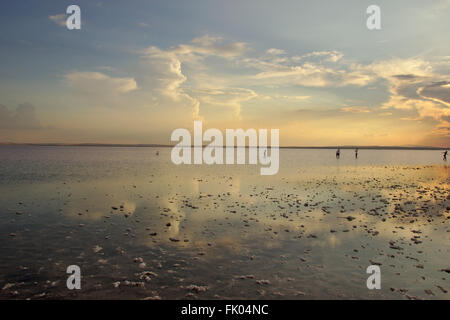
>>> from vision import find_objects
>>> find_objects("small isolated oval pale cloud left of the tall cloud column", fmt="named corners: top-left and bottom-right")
top-left (64, 71), bottom-right (138, 95)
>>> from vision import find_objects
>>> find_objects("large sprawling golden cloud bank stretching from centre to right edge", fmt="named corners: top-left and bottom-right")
top-left (137, 35), bottom-right (448, 144)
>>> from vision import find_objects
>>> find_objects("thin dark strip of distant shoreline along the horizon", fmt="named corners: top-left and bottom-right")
top-left (0, 143), bottom-right (449, 150)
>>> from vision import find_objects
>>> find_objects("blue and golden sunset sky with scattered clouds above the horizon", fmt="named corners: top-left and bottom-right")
top-left (0, 0), bottom-right (450, 147)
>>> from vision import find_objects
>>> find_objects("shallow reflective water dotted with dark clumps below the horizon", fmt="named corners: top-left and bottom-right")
top-left (0, 146), bottom-right (450, 299)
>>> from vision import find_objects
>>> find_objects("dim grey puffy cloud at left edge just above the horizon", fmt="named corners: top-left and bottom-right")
top-left (0, 103), bottom-right (42, 130)
